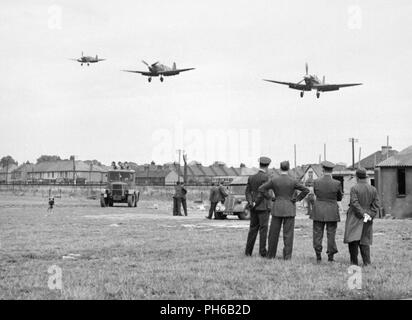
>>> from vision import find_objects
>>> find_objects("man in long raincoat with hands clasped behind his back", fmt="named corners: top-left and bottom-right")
top-left (343, 168), bottom-right (380, 266)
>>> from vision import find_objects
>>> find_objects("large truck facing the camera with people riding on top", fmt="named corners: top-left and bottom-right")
top-left (100, 169), bottom-right (140, 207)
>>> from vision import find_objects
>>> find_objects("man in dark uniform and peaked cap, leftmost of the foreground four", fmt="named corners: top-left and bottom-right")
top-left (245, 157), bottom-right (271, 257)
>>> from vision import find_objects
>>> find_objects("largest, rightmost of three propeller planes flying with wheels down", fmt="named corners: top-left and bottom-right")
top-left (263, 63), bottom-right (362, 98)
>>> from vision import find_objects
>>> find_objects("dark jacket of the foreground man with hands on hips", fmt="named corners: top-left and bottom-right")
top-left (256, 174), bottom-right (309, 217)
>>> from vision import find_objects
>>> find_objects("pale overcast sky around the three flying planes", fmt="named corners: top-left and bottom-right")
top-left (0, 0), bottom-right (412, 166)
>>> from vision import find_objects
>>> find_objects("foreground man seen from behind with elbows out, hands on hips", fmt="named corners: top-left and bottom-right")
top-left (256, 161), bottom-right (309, 260)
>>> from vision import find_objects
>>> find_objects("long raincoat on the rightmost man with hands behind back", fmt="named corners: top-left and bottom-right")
top-left (343, 181), bottom-right (380, 245)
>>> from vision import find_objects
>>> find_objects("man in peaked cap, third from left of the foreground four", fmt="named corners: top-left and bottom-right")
top-left (310, 161), bottom-right (343, 262)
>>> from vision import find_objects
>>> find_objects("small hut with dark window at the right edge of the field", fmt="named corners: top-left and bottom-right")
top-left (375, 146), bottom-right (412, 218)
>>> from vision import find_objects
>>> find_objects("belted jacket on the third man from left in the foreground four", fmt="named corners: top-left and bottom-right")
top-left (310, 175), bottom-right (343, 222)
